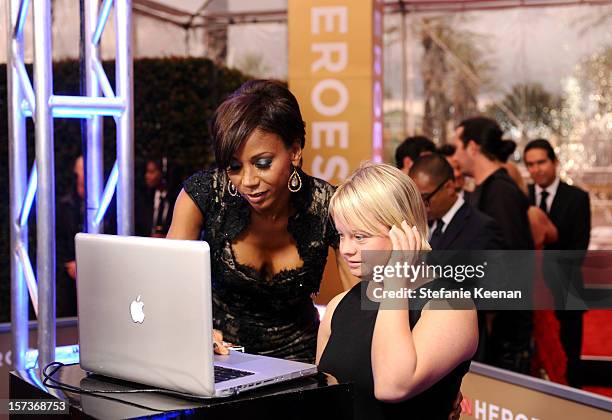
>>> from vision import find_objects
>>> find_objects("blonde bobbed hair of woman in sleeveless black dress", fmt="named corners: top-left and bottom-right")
top-left (329, 162), bottom-right (431, 250)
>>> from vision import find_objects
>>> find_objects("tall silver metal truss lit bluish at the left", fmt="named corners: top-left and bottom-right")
top-left (5, 0), bottom-right (134, 369)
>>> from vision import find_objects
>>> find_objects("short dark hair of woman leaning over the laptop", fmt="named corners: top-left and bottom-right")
top-left (210, 80), bottom-right (306, 169)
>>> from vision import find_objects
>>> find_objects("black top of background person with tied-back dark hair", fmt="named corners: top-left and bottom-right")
top-left (470, 168), bottom-right (533, 249)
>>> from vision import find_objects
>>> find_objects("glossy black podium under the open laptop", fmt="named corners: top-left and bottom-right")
top-left (9, 365), bottom-right (353, 420)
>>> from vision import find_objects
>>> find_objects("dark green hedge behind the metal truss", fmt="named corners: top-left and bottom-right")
top-left (0, 58), bottom-right (247, 322)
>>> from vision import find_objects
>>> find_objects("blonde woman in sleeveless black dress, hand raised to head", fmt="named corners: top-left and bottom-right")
top-left (316, 163), bottom-right (478, 419)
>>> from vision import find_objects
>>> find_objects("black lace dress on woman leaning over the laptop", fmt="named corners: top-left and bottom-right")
top-left (183, 169), bottom-right (338, 362)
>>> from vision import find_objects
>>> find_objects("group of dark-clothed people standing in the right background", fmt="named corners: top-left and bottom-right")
top-left (395, 117), bottom-right (591, 387)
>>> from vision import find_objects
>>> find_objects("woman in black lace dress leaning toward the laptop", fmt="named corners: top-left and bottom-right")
top-left (168, 80), bottom-right (349, 362)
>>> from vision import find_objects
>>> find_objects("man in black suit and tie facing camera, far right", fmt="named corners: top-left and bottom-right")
top-left (524, 139), bottom-right (591, 388)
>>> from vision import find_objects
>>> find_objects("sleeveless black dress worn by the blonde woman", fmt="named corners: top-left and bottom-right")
top-left (319, 283), bottom-right (470, 420)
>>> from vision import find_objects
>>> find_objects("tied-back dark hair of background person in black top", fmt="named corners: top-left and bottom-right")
top-left (458, 117), bottom-right (516, 162)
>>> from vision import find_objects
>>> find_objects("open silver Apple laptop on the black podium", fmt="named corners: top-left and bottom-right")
top-left (75, 233), bottom-right (317, 397)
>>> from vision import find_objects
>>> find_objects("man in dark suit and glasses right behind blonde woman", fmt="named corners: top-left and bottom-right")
top-left (410, 154), bottom-right (502, 362)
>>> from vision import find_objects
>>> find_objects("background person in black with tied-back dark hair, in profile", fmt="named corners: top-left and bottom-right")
top-left (454, 117), bottom-right (534, 373)
